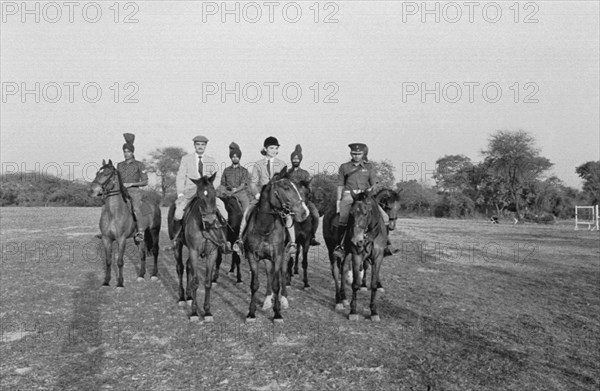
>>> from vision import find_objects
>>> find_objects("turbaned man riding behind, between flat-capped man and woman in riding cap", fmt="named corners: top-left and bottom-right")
top-left (217, 142), bottom-right (250, 212)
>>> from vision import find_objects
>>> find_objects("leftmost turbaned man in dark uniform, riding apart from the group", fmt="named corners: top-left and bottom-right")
top-left (117, 133), bottom-right (148, 242)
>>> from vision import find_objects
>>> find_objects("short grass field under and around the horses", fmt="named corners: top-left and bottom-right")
top-left (0, 208), bottom-right (600, 390)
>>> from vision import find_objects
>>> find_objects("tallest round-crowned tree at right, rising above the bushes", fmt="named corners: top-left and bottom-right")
top-left (482, 130), bottom-right (553, 216)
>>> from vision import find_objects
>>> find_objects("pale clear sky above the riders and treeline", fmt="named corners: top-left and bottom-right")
top-left (0, 1), bottom-right (600, 188)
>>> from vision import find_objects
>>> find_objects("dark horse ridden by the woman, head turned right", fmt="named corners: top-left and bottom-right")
top-left (243, 167), bottom-right (309, 322)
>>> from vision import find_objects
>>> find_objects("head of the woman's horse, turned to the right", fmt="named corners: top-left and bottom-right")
top-left (269, 173), bottom-right (310, 223)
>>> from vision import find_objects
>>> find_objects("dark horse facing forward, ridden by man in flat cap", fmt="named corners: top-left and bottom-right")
top-left (168, 173), bottom-right (223, 322)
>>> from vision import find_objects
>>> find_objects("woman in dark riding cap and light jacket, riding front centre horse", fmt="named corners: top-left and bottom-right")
top-left (235, 136), bottom-right (296, 254)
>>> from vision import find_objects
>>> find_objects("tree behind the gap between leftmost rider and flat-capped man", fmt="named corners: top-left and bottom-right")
top-left (144, 147), bottom-right (187, 202)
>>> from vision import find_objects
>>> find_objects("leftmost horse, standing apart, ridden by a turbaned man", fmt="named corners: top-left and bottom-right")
top-left (91, 160), bottom-right (161, 287)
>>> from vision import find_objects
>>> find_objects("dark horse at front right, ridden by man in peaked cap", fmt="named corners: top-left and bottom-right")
top-left (323, 192), bottom-right (387, 321)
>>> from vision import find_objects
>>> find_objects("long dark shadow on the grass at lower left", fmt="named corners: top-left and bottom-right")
top-left (55, 273), bottom-right (107, 390)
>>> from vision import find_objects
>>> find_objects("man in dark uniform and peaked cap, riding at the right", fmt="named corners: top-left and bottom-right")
top-left (334, 143), bottom-right (392, 258)
